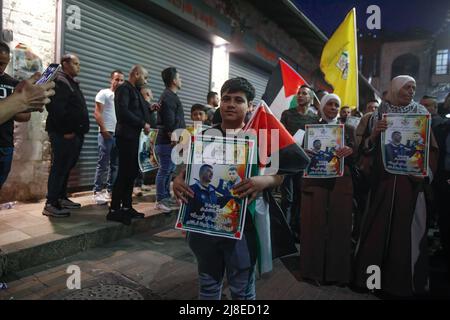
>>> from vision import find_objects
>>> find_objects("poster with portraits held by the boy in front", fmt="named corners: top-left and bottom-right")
top-left (175, 135), bottom-right (255, 240)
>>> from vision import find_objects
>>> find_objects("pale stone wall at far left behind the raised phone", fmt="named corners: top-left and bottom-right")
top-left (0, 0), bottom-right (57, 203)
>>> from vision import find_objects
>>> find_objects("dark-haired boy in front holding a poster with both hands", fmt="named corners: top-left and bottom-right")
top-left (173, 78), bottom-right (283, 300)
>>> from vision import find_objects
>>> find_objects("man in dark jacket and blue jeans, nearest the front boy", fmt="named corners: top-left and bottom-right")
top-left (155, 68), bottom-right (186, 213)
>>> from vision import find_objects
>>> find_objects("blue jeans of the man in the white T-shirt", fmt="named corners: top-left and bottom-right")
top-left (94, 132), bottom-right (119, 192)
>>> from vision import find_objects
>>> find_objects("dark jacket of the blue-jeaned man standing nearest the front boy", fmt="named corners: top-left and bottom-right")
top-left (156, 89), bottom-right (186, 144)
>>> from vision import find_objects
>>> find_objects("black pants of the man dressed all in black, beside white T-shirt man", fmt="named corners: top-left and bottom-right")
top-left (111, 137), bottom-right (139, 210)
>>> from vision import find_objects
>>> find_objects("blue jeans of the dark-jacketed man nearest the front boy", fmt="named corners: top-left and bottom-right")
top-left (155, 144), bottom-right (175, 202)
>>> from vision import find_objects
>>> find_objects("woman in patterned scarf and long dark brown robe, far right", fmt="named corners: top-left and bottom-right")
top-left (355, 76), bottom-right (437, 297)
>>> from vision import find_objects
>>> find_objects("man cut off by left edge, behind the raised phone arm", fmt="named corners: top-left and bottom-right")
top-left (0, 42), bottom-right (31, 189)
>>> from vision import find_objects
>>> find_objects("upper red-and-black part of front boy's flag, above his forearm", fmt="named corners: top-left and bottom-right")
top-left (244, 101), bottom-right (310, 175)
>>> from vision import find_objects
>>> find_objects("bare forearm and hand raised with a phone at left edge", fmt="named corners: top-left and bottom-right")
top-left (0, 73), bottom-right (55, 124)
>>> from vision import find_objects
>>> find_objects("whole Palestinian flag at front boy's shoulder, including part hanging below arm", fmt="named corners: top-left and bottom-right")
top-left (244, 101), bottom-right (310, 274)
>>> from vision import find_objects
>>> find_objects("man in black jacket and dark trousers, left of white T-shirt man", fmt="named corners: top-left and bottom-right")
top-left (43, 54), bottom-right (89, 217)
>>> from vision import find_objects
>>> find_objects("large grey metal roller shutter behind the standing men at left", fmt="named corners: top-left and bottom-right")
top-left (63, 0), bottom-right (212, 187)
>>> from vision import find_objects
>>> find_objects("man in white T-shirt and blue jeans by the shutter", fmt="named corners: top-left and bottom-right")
top-left (94, 70), bottom-right (124, 205)
